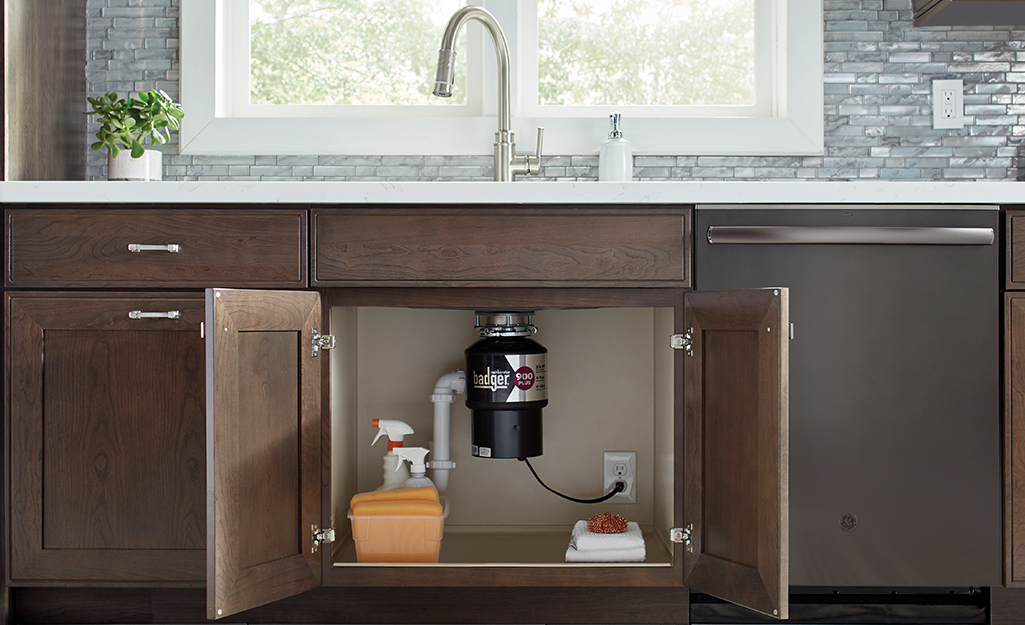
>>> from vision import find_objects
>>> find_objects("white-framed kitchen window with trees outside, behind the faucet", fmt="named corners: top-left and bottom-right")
top-left (180, 0), bottom-right (823, 155)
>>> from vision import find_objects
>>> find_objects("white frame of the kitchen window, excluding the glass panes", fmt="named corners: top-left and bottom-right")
top-left (179, 0), bottom-right (824, 156)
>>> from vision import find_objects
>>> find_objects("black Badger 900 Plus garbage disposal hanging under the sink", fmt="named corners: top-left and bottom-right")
top-left (465, 314), bottom-right (548, 458)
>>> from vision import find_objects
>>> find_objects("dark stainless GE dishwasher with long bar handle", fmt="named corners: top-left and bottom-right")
top-left (694, 206), bottom-right (1001, 588)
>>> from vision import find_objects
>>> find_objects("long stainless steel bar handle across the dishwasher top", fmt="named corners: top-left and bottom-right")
top-left (707, 225), bottom-right (995, 245)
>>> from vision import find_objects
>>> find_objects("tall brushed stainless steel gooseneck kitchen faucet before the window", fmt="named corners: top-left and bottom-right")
top-left (435, 6), bottom-right (544, 181)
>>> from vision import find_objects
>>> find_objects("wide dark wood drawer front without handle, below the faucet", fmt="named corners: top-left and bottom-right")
top-left (314, 207), bottom-right (691, 287)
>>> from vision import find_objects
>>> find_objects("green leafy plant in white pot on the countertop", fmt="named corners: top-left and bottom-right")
top-left (85, 89), bottom-right (186, 180)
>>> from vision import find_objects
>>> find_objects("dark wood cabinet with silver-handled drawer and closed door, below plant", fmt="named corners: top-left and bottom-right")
top-left (4, 206), bottom-right (308, 586)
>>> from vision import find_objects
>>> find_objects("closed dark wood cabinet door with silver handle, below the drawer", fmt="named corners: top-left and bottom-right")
top-left (7, 294), bottom-right (206, 582)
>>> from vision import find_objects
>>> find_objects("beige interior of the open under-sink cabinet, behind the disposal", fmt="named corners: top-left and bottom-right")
top-left (330, 306), bottom-right (677, 567)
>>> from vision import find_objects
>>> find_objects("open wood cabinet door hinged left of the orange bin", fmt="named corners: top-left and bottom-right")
top-left (206, 289), bottom-right (322, 619)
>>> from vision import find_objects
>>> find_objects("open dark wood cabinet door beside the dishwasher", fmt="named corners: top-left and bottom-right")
top-left (684, 288), bottom-right (789, 619)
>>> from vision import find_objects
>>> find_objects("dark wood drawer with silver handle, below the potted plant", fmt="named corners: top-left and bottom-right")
top-left (6, 207), bottom-right (306, 288)
